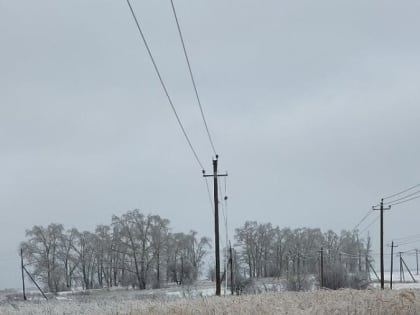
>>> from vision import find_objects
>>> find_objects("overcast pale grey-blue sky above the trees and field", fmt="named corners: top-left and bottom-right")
top-left (0, 0), bottom-right (420, 287)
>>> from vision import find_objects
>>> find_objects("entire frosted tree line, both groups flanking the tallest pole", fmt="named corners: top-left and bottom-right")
top-left (21, 215), bottom-right (371, 292)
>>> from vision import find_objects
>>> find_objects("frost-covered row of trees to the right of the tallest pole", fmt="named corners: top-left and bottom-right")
top-left (235, 221), bottom-right (371, 278)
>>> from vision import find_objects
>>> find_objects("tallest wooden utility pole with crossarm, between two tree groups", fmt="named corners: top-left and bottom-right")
top-left (203, 155), bottom-right (227, 296)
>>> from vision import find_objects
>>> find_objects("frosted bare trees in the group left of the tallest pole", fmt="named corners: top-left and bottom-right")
top-left (21, 210), bottom-right (211, 292)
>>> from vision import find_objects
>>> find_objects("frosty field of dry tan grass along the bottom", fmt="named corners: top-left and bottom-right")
top-left (0, 282), bottom-right (420, 315)
